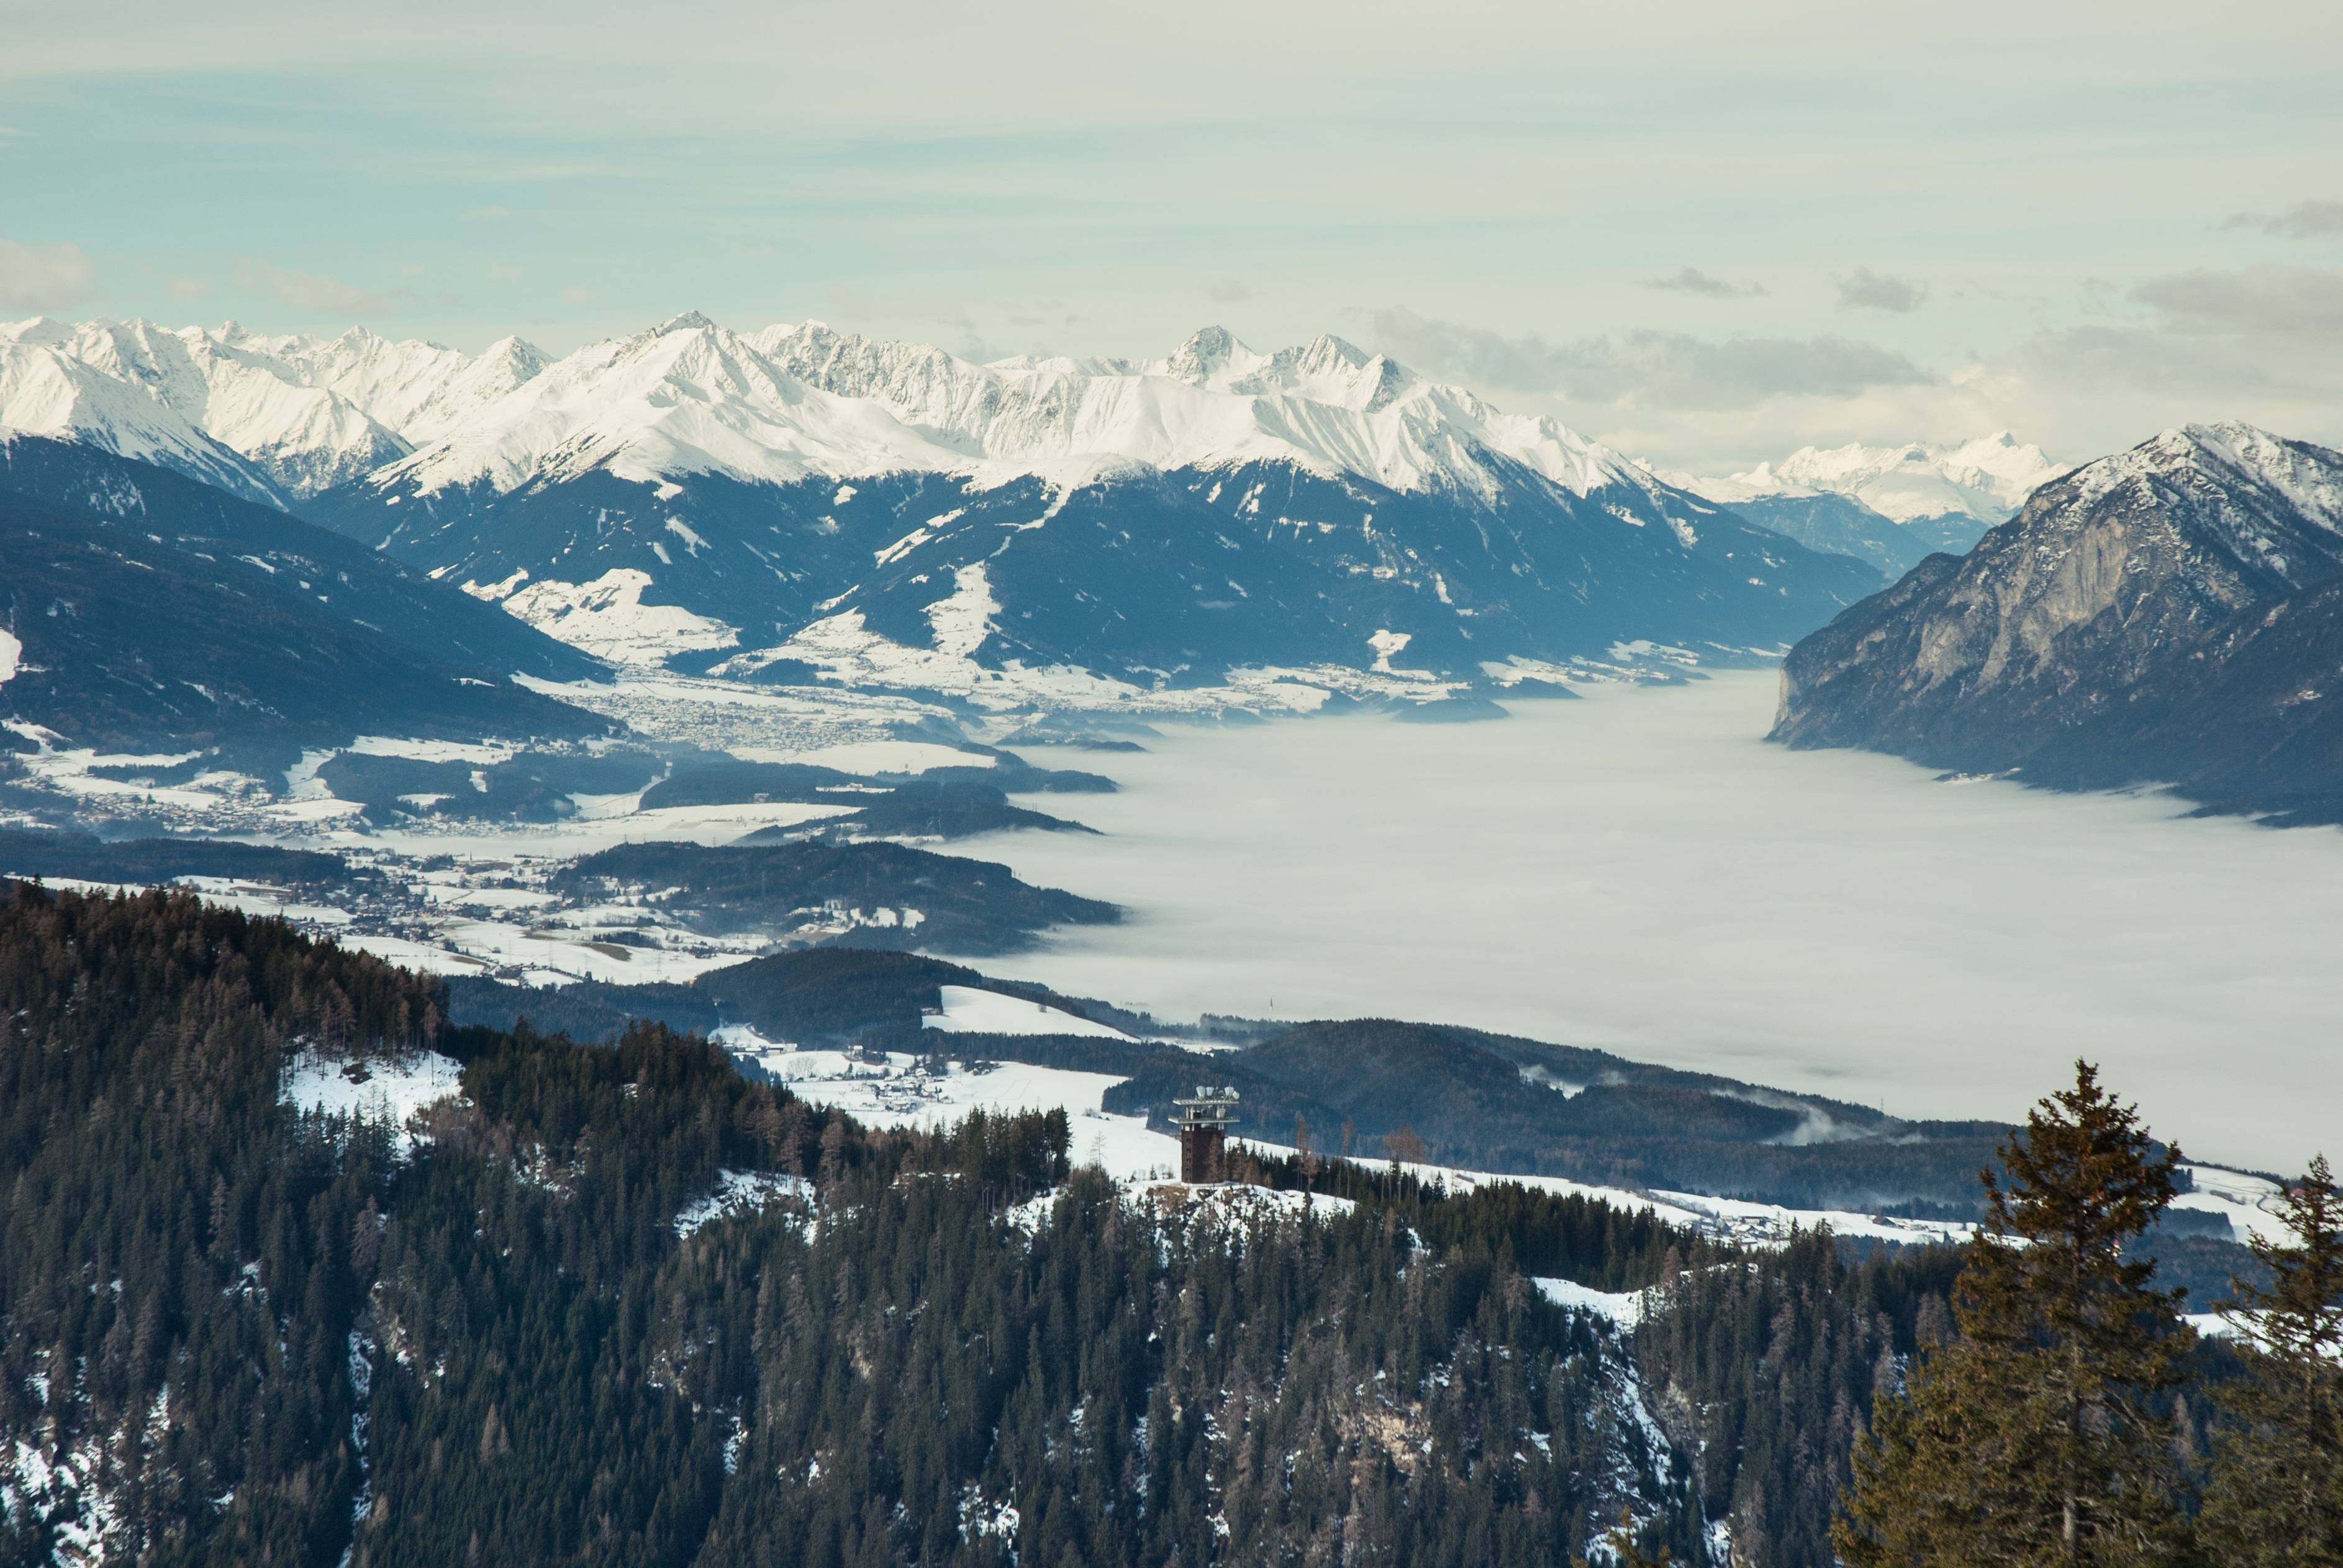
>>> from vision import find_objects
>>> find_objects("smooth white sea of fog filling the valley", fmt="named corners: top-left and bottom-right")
top-left (979, 673), bottom-right (2343, 1172)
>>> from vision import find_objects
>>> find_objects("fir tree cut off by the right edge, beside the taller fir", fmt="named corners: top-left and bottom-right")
top-left (2203, 1156), bottom-right (2343, 1568)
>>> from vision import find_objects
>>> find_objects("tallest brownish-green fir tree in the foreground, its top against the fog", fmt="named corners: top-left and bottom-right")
top-left (1832, 1062), bottom-right (2195, 1568)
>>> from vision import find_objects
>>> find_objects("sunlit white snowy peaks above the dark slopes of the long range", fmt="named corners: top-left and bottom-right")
top-left (0, 312), bottom-right (1649, 510)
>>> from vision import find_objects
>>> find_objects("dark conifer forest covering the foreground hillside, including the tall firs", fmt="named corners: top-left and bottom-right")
top-left (0, 886), bottom-right (2343, 1568)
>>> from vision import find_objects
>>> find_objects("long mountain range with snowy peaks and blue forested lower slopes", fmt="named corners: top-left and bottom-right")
top-left (0, 314), bottom-right (1877, 691)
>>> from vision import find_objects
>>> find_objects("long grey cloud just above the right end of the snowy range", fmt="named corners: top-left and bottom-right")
top-left (1373, 309), bottom-right (1937, 410)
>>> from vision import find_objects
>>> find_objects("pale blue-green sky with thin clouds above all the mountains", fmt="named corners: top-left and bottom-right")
top-left (0, 0), bottom-right (2343, 473)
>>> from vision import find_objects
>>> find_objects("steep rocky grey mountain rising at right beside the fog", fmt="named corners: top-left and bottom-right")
top-left (1774, 424), bottom-right (2343, 802)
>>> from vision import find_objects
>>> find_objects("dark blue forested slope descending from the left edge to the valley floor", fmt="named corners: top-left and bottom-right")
top-left (0, 436), bottom-right (609, 755)
